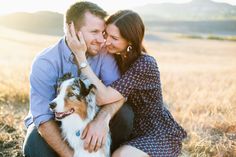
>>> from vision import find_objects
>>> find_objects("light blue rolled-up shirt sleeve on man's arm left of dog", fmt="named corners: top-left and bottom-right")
top-left (30, 58), bottom-right (57, 127)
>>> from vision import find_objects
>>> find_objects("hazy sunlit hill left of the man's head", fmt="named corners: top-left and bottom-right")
top-left (0, 11), bottom-right (63, 35)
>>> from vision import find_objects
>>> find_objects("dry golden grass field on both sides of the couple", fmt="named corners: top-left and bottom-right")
top-left (0, 27), bottom-right (236, 157)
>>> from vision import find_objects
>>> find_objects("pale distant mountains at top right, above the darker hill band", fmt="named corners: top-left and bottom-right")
top-left (135, 0), bottom-right (236, 21)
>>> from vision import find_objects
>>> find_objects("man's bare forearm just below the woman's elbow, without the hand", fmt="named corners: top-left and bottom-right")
top-left (95, 99), bottom-right (125, 123)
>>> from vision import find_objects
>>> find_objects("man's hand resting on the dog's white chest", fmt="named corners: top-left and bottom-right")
top-left (81, 114), bottom-right (110, 153)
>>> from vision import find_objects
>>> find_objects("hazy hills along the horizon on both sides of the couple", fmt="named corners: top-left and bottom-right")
top-left (0, 0), bottom-right (236, 36)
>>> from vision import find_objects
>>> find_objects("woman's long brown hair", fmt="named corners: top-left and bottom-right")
top-left (106, 10), bottom-right (146, 74)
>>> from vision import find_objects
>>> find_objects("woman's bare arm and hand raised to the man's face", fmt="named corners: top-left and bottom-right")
top-left (66, 23), bottom-right (124, 105)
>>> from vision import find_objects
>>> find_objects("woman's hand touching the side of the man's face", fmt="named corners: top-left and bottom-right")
top-left (66, 22), bottom-right (87, 59)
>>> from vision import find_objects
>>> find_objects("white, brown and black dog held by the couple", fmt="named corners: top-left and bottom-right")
top-left (49, 74), bottom-right (111, 157)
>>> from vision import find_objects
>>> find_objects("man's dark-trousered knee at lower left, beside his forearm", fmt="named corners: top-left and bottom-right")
top-left (23, 126), bottom-right (58, 157)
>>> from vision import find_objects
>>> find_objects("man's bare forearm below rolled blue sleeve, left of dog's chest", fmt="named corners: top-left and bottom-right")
top-left (38, 120), bottom-right (73, 157)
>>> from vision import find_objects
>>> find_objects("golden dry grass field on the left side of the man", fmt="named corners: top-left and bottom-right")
top-left (0, 27), bottom-right (59, 157)
